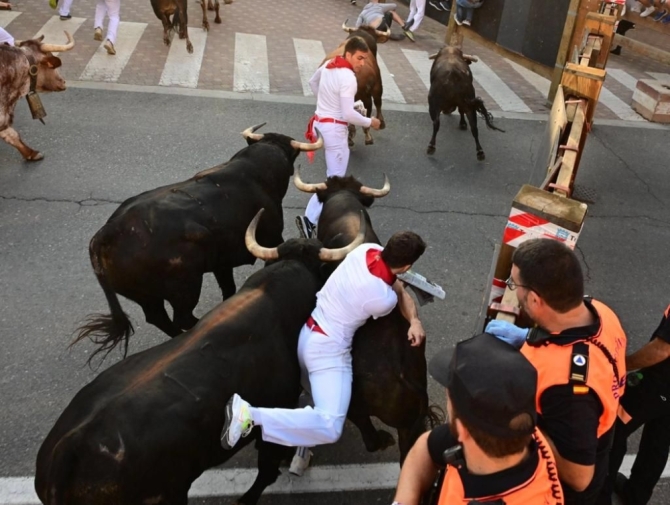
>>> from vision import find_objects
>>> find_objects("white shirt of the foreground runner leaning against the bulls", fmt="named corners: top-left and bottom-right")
top-left (312, 244), bottom-right (398, 348)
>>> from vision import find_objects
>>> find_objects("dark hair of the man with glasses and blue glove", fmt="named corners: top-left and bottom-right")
top-left (512, 238), bottom-right (584, 313)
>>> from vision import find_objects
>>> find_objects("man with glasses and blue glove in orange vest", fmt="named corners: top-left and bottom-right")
top-left (486, 239), bottom-right (626, 505)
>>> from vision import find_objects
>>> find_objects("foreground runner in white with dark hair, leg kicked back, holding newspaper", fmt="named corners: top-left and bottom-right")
top-left (221, 231), bottom-right (426, 456)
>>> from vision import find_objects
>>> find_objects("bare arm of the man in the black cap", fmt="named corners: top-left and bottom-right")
top-left (394, 432), bottom-right (437, 505)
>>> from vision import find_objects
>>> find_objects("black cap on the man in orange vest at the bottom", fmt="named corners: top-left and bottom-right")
top-left (428, 333), bottom-right (537, 438)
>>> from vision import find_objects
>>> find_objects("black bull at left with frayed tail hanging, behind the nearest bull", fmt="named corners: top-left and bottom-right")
top-left (74, 125), bottom-right (323, 362)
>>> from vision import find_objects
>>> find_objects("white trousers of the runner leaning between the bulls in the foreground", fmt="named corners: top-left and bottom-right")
top-left (251, 326), bottom-right (353, 447)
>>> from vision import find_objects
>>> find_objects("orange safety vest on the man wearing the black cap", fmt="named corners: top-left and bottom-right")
top-left (437, 429), bottom-right (565, 505)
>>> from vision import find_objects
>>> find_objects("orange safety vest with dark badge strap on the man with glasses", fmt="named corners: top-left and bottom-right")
top-left (521, 300), bottom-right (626, 438)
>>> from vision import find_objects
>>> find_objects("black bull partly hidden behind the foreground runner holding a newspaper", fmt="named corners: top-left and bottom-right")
top-left (294, 169), bottom-right (440, 456)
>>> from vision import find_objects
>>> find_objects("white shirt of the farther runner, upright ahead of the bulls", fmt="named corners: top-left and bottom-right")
top-left (309, 60), bottom-right (371, 128)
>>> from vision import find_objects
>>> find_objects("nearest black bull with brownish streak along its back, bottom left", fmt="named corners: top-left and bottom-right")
top-left (35, 213), bottom-right (364, 505)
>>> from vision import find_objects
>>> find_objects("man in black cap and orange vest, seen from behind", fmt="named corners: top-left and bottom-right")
top-left (394, 333), bottom-right (564, 505)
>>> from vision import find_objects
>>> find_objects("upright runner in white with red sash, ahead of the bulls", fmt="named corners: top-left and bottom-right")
top-left (296, 37), bottom-right (380, 238)
